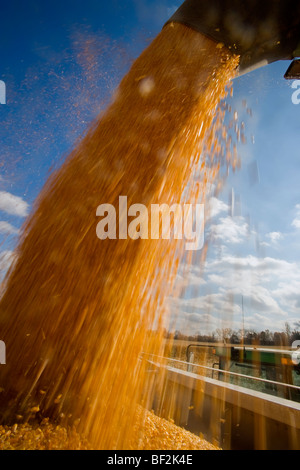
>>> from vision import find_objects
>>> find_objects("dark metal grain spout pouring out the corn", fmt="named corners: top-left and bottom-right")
top-left (167, 0), bottom-right (300, 78)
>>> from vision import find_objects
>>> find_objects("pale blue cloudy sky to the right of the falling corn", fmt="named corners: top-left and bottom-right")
top-left (171, 61), bottom-right (300, 334)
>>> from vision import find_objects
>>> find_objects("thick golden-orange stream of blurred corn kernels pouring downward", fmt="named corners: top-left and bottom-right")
top-left (0, 24), bottom-right (238, 449)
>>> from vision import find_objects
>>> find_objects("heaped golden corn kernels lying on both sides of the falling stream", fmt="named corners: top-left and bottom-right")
top-left (0, 412), bottom-right (218, 450)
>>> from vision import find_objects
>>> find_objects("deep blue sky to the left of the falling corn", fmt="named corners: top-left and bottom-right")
top-left (0, 0), bottom-right (172, 248)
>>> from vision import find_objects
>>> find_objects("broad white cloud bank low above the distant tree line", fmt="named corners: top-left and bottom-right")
top-left (170, 255), bottom-right (300, 334)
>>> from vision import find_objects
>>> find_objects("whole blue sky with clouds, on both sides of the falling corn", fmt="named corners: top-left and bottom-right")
top-left (0, 0), bottom-right (300, 338)
